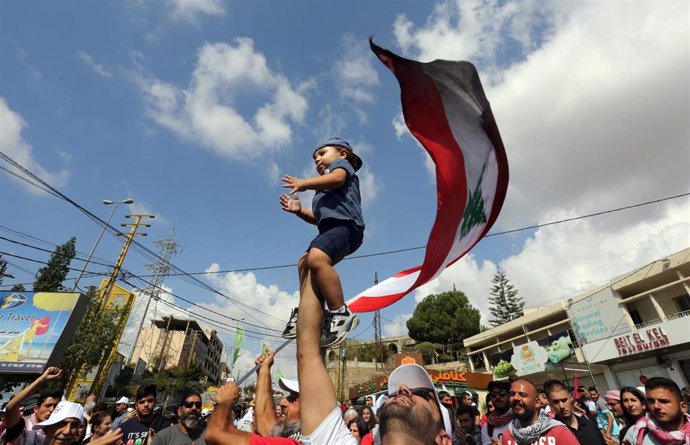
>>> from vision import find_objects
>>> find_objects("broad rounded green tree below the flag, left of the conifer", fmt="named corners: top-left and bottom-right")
top-left (407, 290), bottom-right (480, 346)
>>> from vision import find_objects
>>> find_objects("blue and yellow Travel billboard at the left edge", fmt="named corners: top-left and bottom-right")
top-left (0, 291), bottom-right (86, 374)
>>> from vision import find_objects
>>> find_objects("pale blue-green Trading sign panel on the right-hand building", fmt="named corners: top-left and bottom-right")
top-left (570, 286), bottom-right (630, 345)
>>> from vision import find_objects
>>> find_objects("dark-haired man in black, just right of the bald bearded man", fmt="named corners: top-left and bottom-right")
top-left (544, 379), bottom-right (606, 445)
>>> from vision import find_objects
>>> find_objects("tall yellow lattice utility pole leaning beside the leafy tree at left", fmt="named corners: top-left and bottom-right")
top-left (91, 215), bottom-right (154, 394)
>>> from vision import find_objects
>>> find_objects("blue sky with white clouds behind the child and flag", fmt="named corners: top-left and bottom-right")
top-left (0, 0), bottom-right (690, 382)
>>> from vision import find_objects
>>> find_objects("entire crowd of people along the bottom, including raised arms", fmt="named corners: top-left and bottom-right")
top-left (0, 354), bottom-right (690, 445)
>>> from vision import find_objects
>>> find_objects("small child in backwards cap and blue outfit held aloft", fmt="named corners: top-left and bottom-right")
top-left (280, 137), bottom-right (364, 348)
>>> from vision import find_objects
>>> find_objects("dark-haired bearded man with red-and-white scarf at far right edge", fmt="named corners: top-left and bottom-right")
top-left (623, 377), bottom-right (690, 445)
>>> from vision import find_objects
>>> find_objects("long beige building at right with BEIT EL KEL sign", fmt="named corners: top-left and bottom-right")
top-left (464, 248), bottom-right (690, 389)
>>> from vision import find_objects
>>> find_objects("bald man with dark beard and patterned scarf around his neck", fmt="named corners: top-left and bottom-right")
top-left (501, 379), bottom-right (580, 445)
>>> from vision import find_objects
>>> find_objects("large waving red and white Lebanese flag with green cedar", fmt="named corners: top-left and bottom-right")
top-left (347, 39), bottom-right (508, 312)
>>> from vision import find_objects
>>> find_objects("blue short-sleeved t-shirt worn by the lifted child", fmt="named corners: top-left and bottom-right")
top-left (311, 159), bottom-right (364, 229)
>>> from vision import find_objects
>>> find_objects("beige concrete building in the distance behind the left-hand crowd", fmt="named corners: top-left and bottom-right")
top-left (132, 317), bottom-right (223, 385)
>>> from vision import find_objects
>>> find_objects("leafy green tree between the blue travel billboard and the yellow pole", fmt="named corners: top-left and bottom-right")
top-left (61, 286), bottom-right (122, 384)
